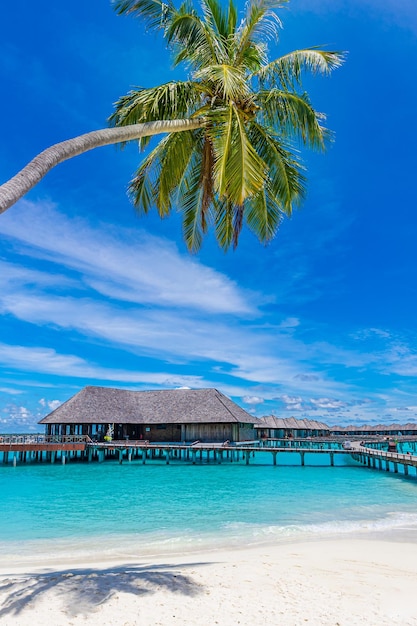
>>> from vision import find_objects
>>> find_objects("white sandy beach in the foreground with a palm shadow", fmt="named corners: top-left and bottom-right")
top-left (0, 540), bottom-right (417, 626)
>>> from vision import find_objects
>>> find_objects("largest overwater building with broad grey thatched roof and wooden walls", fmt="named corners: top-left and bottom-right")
top-left (39, 387), bottom-right (256, 443)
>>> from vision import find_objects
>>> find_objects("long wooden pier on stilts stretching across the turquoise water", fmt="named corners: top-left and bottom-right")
top-left (0, 435), bottom-right (417, 475)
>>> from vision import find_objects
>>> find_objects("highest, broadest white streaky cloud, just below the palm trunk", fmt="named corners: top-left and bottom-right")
top-left (0, 201), bottom-right (256, 315)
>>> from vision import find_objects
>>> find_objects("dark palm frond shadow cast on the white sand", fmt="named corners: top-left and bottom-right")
top-left (0, 563), bottom-right (208, 622)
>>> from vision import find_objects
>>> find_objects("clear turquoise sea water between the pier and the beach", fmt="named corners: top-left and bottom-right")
top-left (0, 454), bottom-right (417, 563)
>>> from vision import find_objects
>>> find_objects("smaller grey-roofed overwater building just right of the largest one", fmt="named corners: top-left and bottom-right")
top-left (255, 415), bottom-right (330, 439)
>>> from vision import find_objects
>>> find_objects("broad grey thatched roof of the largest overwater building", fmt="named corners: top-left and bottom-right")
top-left (39, 387), bottom-right (255, 424)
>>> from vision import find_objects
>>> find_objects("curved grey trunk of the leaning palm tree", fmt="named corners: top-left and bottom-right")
top-left (0, 118), bottom-right (205, 213)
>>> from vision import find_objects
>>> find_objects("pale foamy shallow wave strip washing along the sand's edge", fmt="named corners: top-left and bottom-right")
top-left (0, 513), bottom-right (417, 566)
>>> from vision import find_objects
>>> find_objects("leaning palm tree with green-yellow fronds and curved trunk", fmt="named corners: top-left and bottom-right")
top-left (0, 0), bottom-right (343, 251)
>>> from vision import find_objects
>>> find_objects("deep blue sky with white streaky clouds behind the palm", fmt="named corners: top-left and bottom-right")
top-left (0, 0), bottom-right (417, 432)
